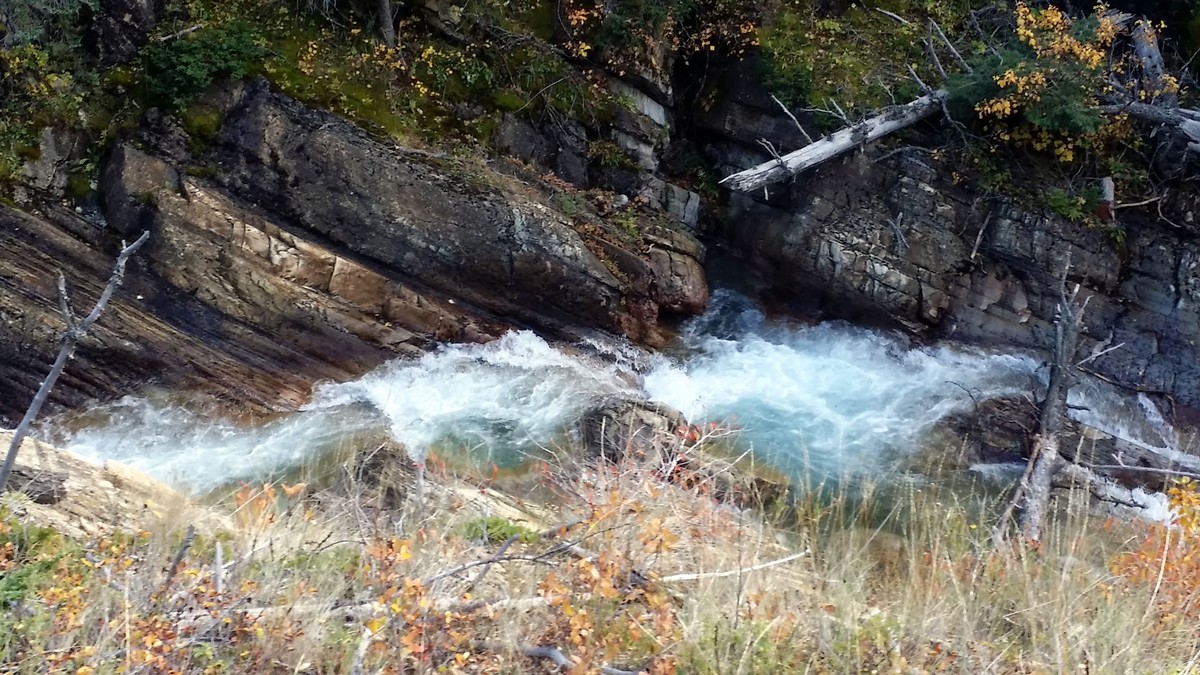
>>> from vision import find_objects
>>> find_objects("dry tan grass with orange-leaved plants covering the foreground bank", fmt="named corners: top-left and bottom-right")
top-left (0, 432), bottom-right (1200, 674)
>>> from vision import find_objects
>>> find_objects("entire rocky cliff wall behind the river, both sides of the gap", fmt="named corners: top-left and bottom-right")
top-left (7, 4), bottom-right (1200, 420)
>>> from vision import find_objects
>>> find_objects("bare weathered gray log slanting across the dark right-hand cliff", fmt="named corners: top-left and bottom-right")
top-left (721, 89), bottom-right (949, 192)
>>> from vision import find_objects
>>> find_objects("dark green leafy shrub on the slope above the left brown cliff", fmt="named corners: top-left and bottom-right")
top-left (142, 22), bottom-right (269, 109)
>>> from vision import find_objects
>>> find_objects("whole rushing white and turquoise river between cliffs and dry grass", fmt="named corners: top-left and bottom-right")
top-left (43, 285), bottom-right (1180, 491)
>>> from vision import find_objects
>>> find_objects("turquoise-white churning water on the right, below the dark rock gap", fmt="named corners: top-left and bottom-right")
top-left (644, 291), bottom-right (1038, 478)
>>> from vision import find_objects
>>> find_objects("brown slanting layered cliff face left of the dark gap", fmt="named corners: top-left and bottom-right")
top-left (0, 77), bottom-right (708, 423)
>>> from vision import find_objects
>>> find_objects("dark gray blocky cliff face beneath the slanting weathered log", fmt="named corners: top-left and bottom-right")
top-left (697, 59), bottom-right (1200, 417)
